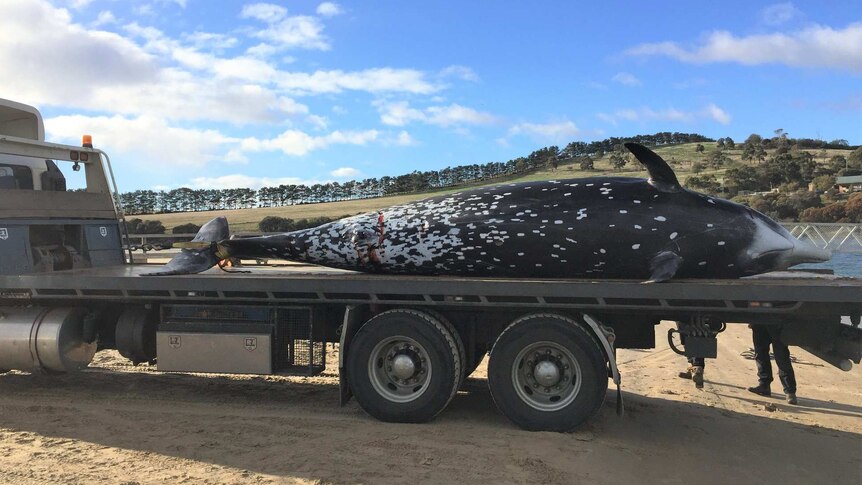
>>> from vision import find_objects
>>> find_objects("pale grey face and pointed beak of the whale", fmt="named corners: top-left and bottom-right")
top-left (745, 207), bottom-right (832, 273)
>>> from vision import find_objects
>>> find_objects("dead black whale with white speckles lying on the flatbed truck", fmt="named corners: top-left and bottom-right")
top-left (147, 143), bottom-right (830, 282)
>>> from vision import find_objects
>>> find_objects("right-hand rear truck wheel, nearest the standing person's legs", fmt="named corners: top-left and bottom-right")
top-left (488, 314), bottom-right (608, 431)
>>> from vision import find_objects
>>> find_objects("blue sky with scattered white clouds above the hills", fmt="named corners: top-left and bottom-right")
top-left (0, 0), bottom-right (862, 191)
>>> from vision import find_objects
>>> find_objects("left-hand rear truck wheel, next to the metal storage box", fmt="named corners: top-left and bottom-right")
top-left (347, 309), bottom-right (461, 423)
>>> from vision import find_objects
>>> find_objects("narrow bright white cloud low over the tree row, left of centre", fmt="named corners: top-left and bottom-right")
top-left (240, 130), bottom-right (380, 156)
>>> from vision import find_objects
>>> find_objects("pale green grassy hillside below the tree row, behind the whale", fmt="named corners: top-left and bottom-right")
top-left (140, 143), bottom-right (850, 232)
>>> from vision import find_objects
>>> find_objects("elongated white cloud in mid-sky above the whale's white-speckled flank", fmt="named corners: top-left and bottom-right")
top-left (375, 101), bottom-right (498, 127)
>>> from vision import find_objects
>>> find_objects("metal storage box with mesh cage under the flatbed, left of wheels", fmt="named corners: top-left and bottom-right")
top-left (156, 305), bottom-right (326, 376)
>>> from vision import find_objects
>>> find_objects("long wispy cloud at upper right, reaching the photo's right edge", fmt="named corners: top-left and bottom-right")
top-left (626, 22), bottom-right (862, 72)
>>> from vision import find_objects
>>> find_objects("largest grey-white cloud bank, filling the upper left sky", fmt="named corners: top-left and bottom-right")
top-left (0, 0), bottom-right (443, 124)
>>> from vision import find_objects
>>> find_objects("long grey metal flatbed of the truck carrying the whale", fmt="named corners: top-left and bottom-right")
top-left (0, 264), bottom-right (862, 321)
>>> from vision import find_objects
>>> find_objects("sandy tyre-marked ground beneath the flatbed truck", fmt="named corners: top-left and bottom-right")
top-left (0, 325), bottom-right (862, 484)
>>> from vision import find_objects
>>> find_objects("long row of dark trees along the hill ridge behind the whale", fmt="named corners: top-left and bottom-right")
top-left (120, 132), bottom-right (713, 215)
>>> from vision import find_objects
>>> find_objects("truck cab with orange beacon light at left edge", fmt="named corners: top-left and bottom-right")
top-left (0, 99), bottom-right (124, 275)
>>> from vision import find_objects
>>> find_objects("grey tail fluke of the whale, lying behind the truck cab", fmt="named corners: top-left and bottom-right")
top-left (143, 217), bottom-right (230, 276)
